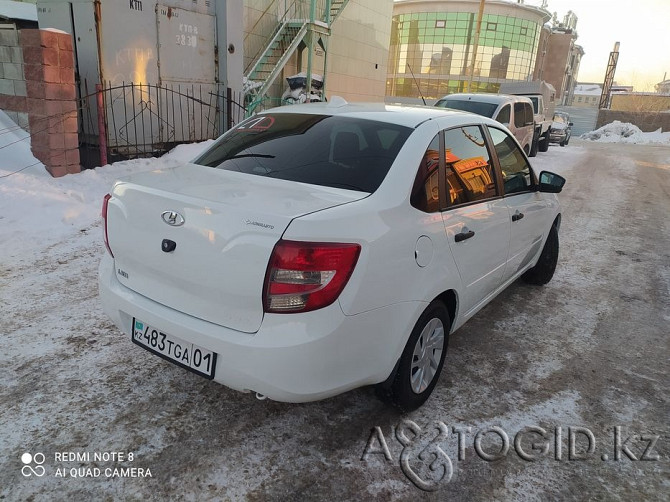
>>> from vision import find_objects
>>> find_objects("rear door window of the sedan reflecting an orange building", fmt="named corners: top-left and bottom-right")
top-left (444, 126), bottom-right (497, 206)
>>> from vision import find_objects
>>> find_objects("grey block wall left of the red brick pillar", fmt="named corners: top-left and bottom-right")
top-left (0, 28), bottom-right (29, 131)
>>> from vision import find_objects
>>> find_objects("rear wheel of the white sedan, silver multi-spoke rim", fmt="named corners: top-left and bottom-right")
top-left (377, 300), bottom-right (451, 412)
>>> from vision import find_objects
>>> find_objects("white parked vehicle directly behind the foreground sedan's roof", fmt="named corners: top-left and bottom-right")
top-left (435, 93), bottom-right (537, 157)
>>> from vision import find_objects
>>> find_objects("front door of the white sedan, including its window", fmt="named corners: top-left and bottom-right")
top-left (487, 126), bottom-right (551, 282)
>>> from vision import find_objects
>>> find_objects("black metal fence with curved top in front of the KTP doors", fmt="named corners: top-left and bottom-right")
top-left (78, 83), bottom-right (245, 164)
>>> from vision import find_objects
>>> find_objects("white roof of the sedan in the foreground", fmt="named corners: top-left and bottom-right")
top-left (262, 96), bottom-right (484, 128)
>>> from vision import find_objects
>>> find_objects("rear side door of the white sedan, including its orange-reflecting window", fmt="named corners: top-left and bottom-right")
top-left (442, 125), bottom-right (510, 315)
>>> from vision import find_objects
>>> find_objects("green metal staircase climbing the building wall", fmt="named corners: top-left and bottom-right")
top-left (245, 0), bottom-right (349, 114)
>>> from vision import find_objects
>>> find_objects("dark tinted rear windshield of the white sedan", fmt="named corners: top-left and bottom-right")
top-left (194, 113), bottom-right (412, 193)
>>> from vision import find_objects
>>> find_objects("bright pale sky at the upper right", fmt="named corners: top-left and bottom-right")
top-left (525, 0), bottom-right (670, 91)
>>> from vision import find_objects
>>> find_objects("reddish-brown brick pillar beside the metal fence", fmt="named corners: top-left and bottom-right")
top-left (19, 29), bottom-right (81, 177)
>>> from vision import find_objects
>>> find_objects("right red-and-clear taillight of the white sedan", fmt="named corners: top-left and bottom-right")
top-left (263, 240), bottom-right (361, 314)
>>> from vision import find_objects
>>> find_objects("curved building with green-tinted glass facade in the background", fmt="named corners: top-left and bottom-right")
top-left (386, 0), bottom-right (551, 101)
